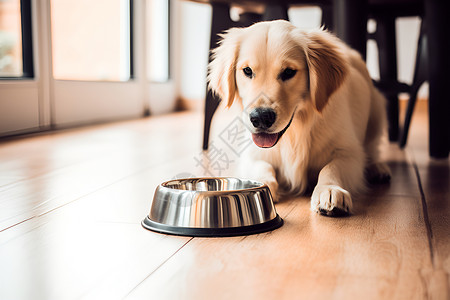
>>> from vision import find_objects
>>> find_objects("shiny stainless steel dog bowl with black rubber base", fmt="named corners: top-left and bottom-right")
top-left (142, 177), bottom-right (283, 237)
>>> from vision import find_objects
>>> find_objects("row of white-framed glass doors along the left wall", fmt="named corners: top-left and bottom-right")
top-left (0, 0), bottom-right (176, 136)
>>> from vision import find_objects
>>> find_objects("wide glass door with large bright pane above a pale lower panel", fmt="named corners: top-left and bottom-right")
top-left (50, 0), bottom-right (144, 126)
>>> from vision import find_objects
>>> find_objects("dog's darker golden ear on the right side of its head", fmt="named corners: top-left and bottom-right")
top-left (304, 30), bottom-right (348, 112)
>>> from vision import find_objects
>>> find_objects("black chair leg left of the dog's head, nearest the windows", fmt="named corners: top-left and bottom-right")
top-left (203, 2), bottom-right (233, 150)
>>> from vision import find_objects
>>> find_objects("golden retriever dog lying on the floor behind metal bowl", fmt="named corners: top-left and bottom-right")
top-left (208, 20), bottom-right (390, 216)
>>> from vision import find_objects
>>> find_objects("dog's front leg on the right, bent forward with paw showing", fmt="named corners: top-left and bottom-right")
top-left (311, 152), bottom-right (364, 216)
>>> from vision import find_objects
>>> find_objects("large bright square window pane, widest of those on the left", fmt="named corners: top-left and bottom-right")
top-left (51, 0), bottom-right (132, 81)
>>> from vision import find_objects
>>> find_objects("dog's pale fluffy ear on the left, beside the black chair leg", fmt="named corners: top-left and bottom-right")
top-left (208, 28), bottom-right (243, 107)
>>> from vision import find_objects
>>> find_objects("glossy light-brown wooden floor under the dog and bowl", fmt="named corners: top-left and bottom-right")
top-left (0, 102), bottom-right (450, 299)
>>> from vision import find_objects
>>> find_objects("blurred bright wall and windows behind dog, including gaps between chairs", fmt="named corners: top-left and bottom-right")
top-left (0, 0), bottom-right (427, 136)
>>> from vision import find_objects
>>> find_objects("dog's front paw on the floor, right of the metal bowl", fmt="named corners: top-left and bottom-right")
top-left (311, 185), bottom-right (352, 217)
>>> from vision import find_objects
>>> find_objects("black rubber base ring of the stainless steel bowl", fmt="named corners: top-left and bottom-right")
top-left (141, 214), bottom-right (283, 237)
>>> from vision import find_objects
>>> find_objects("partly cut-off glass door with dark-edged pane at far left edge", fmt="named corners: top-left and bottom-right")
top-left (0, 0), bottom-right (40, 135)
